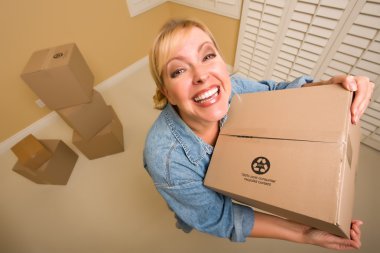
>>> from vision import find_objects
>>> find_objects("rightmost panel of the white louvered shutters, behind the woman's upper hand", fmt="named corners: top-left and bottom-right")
top-left (322, 1), bottom-right (380, 150)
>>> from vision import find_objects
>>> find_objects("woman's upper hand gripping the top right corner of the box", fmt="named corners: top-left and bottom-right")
top-left (326, 75), bottom-right (375, 124)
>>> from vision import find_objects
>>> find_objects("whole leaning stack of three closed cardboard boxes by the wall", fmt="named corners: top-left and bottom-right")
top-left (21, 43), bottom-right (124, 159)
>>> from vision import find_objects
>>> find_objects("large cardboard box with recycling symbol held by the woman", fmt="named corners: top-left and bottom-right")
top-left (204, 85), bottom-right (360, 238)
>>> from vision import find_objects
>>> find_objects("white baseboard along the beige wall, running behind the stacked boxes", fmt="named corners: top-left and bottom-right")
top-left (0, 56), bottom-right (148, 154)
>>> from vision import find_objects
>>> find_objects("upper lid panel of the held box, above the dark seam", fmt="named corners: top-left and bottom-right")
top-left (220, 85), bottom-right (352, 142)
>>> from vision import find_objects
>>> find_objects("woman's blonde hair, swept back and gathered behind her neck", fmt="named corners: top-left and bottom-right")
top-left (149, 19), bottom-right (220, 110)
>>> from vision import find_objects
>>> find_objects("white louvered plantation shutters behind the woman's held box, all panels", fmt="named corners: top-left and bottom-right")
top-left (234, 0), bottom-right (380, 150)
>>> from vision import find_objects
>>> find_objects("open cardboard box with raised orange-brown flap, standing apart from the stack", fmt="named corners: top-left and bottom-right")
top-left (12, 134), bottom-right (78, 185)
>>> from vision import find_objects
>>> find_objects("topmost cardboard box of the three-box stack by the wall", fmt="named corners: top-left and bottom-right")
top-left (21, 43), bottom-right (94, 110)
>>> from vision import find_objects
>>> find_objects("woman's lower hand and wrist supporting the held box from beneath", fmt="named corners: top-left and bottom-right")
top-left (304, 220), bottom-right (363, 250)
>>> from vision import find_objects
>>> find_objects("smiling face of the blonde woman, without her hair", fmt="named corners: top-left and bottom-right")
top-left (163, 27), bottom-right (231, 128)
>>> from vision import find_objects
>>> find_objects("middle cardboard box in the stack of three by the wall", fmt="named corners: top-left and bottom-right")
top-left (57, 90), bottom-right (113, 140)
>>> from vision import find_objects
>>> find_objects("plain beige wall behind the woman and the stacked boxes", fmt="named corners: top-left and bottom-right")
top-left (0, 0), bottom-right (238, 142)
